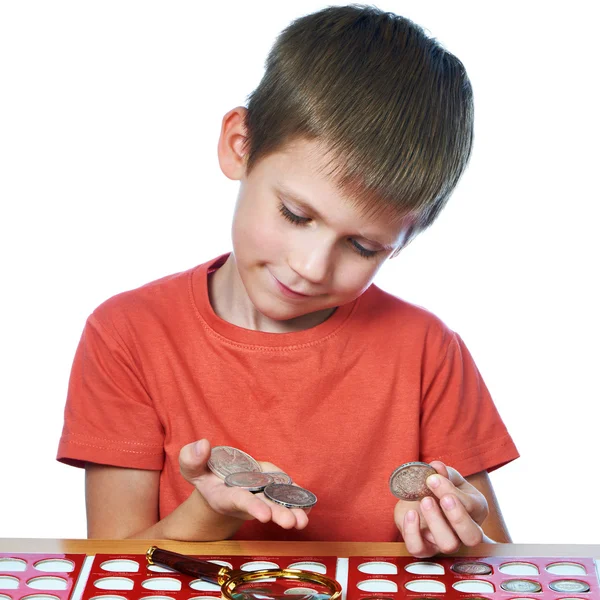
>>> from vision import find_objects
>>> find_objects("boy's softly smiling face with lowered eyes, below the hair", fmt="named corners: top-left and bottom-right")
top-left (219, 112), bottom-right (411, 328)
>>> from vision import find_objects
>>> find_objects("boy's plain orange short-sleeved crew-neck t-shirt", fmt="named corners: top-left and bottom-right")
top-left (57, 251), bottom-right (518, 541)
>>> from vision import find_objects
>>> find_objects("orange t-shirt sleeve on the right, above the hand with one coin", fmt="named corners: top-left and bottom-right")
top-left (421, 332), bottom-right (519, 476)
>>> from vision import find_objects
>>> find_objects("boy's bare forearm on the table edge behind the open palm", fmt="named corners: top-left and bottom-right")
top-left (127, 489), bottom-right (244, 542)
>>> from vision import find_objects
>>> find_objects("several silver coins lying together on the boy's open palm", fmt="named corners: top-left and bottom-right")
top-left (208, 446), bottom-right (317, 508)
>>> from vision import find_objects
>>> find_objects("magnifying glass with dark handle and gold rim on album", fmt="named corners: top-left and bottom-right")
top-left (146, 546), bottom-right (342, 600)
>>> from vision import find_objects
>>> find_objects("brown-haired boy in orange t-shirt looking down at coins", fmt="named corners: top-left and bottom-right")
top-left (58, 6), bottom-right (518, 556)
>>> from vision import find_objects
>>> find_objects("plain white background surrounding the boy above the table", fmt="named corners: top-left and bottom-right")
top-left (0, 0), bottom-right (600, 543)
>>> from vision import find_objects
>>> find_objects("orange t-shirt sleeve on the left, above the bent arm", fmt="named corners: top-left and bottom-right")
top-left (57, 315), bottom-right (164, 470)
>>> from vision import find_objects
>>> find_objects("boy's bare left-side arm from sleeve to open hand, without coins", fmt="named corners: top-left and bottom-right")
top-left (85, 440), bottom-right (308, 541)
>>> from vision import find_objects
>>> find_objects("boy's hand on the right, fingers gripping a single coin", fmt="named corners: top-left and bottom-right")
top-left (394, 461), bottom-right (491, 558)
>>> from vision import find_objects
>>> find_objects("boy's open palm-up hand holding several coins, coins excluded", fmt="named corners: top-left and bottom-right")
top-left (179, 440), bottom-right (310, 529)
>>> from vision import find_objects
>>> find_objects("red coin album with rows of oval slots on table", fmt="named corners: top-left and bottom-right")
top-left (0, 553), bottom-right (600, 600)
